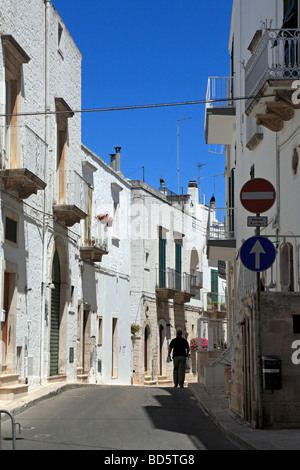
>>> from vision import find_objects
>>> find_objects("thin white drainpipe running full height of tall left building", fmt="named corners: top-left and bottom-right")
top-left (40, 0), bottom-right (51, 385)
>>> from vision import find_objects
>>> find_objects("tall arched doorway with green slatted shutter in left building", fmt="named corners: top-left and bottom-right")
top-left (50, 250), bottom-right (61, 377)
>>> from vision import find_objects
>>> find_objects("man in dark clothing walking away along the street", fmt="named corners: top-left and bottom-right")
top-left (169, 330), bottom-right (190, 388)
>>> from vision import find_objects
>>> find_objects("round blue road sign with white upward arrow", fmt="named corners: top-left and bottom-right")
top-left (240, 237), bottom-right (276, 272)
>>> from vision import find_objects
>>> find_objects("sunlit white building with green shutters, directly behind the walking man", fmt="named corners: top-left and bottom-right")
top-left (131, 176), bottom-right (223, 384)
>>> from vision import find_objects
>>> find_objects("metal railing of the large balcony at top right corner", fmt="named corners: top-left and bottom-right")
top-left (245, 29), bottom-right (300, 108)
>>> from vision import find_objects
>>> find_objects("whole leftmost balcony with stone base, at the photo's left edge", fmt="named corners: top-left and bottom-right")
top-left (0, 126), bottom-right (47, 199)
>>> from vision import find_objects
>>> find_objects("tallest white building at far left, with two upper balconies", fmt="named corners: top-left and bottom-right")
top-left (0, 0), bottom-right (88, 396)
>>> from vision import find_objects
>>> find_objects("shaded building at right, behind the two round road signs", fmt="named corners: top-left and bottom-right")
top-left (205, 0), bottom-right (300, 427)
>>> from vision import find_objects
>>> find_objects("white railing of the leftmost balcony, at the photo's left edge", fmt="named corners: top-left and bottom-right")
top-left (0, 126), bottom-right (47, 181)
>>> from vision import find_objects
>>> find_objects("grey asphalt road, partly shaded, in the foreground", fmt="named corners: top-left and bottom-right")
top-left (2, 386), bottom-right (236, 455)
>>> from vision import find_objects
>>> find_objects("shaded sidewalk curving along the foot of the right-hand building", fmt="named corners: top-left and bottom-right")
top-left (188, 383), bottom-right (300, 450)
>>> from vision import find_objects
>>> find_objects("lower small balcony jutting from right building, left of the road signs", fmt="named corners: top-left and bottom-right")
top-left (206, 205), bottom-right (236, 261)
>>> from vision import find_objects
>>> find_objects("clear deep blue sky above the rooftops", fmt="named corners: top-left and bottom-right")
top-left (52, 0), bottom-right (232, 207)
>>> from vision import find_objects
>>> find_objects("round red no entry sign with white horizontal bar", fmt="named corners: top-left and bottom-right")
top-left (240, 178), bottom-right (276, 214)
